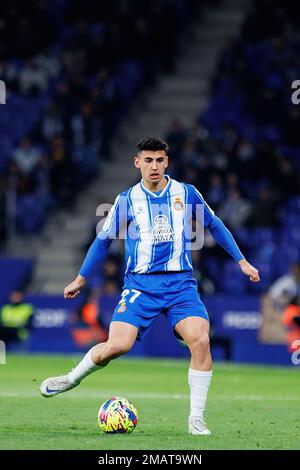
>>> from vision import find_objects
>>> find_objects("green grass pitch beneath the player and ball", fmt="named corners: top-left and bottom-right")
top-left (0, 355), bottom-right (300, 450)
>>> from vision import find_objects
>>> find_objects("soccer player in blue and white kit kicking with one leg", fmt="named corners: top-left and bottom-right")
top-left (40, 137), bottom-right (260, 435)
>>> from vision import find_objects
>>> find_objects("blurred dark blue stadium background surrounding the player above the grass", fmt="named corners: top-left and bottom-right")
top-left (0, 0), bottom-right (300, 364)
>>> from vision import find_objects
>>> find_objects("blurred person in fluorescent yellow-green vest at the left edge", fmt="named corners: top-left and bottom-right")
top-left (0, 291), bottom-right (34, 344)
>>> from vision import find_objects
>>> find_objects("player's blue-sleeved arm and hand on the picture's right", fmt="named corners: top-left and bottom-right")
top-left (195, 188), bottom-right (260, 282)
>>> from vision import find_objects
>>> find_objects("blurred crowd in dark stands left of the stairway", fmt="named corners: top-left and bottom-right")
top-left (0, 0), bottom-right (197, 240)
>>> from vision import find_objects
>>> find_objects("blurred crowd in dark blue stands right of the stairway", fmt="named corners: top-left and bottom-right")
top-left (167, 0), bottom-right (300, 292)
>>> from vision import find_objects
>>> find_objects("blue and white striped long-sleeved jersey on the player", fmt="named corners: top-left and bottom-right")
top-left (80, 175), bottom-right (243, 277)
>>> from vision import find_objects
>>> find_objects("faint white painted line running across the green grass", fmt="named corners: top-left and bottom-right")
top-left (0, 391), bottom-right (300, 402)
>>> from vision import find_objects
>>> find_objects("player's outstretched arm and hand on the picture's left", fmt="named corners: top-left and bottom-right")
top-left (64, 195), bottom-right (121, 299)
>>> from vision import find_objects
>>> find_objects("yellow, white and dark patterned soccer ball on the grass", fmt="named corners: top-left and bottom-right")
top-left (98, 397), bottom-right (138, 433)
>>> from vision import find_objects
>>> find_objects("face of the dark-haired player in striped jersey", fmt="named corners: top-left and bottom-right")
top-left (134, 150), bottom-right (168, 184)
